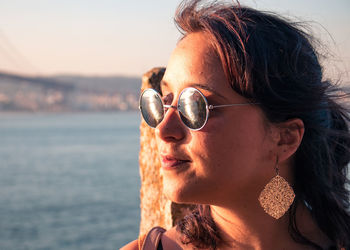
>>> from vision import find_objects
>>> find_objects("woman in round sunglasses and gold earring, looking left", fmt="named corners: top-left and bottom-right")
top-left (123, 1), bottom-right (350, 249)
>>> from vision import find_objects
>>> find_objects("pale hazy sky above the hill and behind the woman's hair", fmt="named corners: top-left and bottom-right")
top-left (0, 0), bottom-right (350, 81)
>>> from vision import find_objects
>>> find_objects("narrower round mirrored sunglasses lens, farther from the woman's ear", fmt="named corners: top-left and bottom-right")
top-left (140, 89), bottom-right (164, 128)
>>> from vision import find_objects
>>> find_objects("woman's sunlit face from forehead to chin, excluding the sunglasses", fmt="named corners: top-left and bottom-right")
top-left (156, 33), bottom-right (274, 205)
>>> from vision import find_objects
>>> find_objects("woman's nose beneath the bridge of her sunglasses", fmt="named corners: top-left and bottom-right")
top-left (156, 106), bottom-right (187, 142)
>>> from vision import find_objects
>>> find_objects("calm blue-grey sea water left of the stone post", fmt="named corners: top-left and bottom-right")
top-left (0, 112), bottom-right (140, 250)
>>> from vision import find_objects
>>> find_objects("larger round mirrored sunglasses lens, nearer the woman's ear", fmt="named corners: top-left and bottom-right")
top-left (178, 88), bottom-right (207, 130)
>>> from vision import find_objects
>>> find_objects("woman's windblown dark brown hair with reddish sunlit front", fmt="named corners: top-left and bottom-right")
top-left (175, 0), bottom-right (350, 249)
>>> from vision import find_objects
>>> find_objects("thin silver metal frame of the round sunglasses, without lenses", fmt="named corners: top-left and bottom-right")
top-left (139, 87), bottom-right (259, 131)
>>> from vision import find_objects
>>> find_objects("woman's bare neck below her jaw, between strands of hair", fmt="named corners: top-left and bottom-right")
top-left (210, 200), bottom-right (332, 249)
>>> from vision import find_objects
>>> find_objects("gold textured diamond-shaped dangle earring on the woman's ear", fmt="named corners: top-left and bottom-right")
top-left (259, 157), bottom-right (295, 219)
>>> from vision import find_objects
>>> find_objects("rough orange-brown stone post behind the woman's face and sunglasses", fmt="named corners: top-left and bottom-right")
top-left (139, 68), bottom-right (191, 234)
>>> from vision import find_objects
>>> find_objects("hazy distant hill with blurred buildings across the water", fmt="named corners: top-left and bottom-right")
top-left (0, 72), bottom-right (141, 112)
